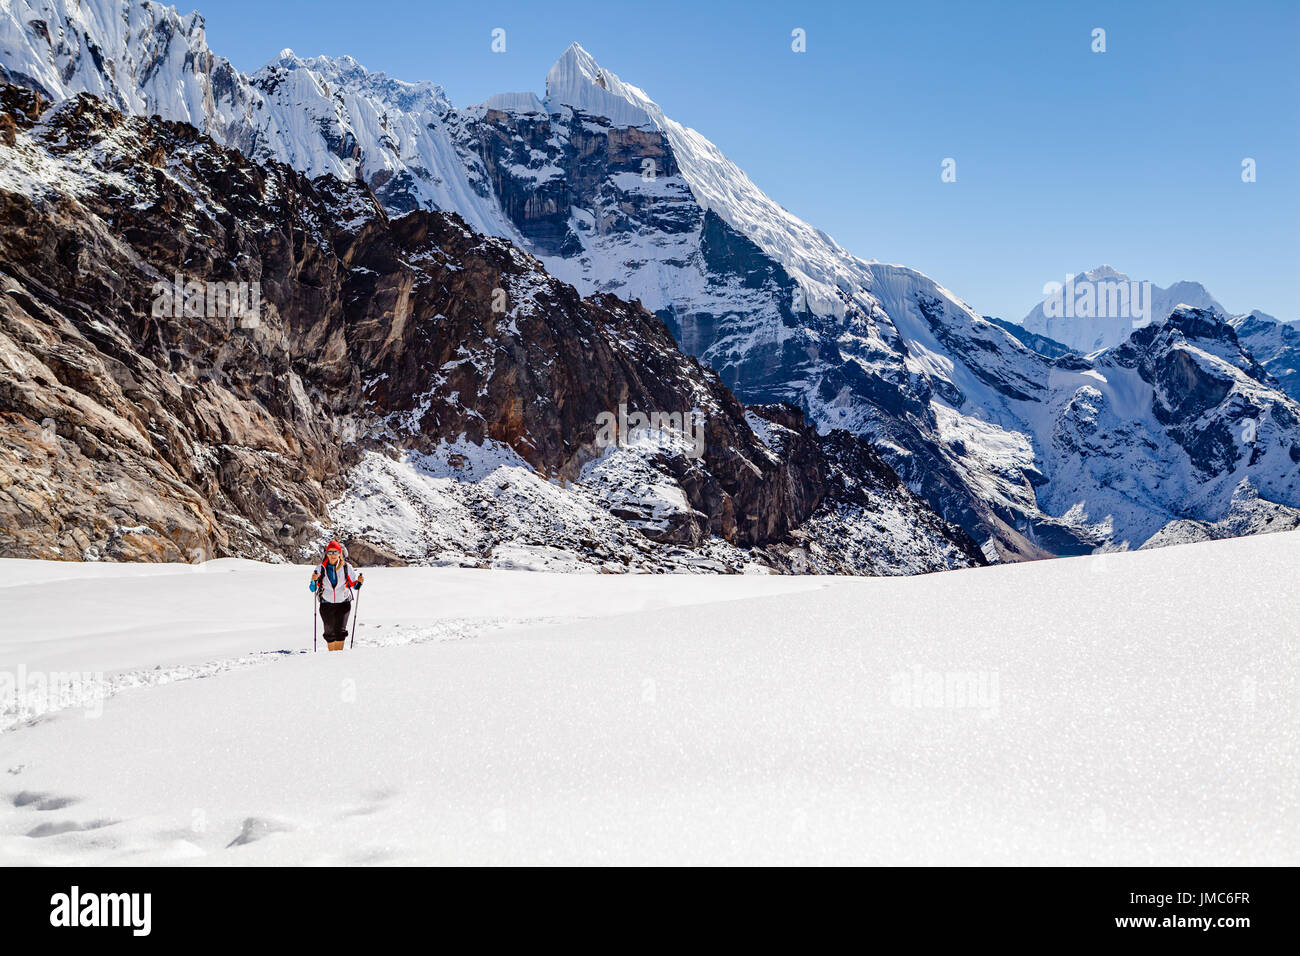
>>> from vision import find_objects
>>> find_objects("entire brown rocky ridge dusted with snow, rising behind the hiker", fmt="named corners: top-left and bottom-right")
top-left (0, 87), bottom-right (978, 571)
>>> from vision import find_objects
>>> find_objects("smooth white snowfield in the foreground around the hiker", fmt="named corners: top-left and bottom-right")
top-left (0, 533), bottom-right (1300, 865)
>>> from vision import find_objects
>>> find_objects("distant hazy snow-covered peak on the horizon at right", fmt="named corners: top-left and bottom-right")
top-left (1021, 265), bottom-right (1227, 355)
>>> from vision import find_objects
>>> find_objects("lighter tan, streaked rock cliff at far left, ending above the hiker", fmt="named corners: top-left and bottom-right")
top-left (0, 87), bottom-right (351, 561)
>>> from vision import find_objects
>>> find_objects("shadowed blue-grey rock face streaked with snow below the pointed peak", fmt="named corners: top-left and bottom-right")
top-left (458, 81), bottom-right (815, 403)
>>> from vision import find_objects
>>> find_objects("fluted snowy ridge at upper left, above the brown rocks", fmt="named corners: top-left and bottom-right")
top-left (0, 0), bottom-right (516, 239)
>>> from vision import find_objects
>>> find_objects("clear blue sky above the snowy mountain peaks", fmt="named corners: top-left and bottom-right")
top-left (195, 0), bottom-right (1300, 319)
